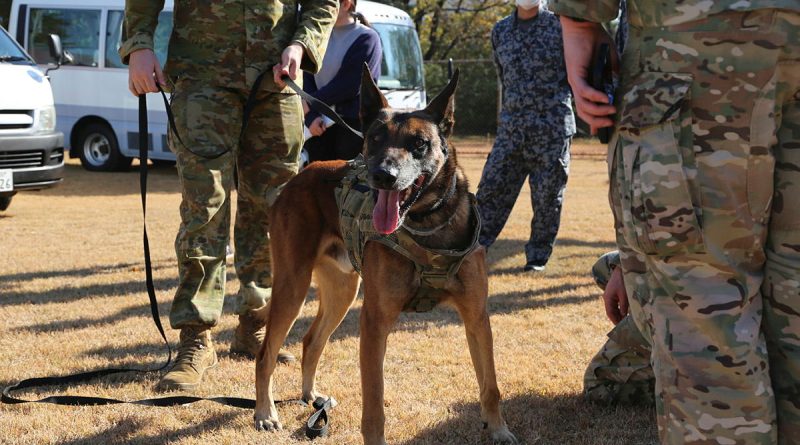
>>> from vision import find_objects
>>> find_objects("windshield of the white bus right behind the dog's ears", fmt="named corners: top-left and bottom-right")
top-left (372, 23), bottom-right (423, 90)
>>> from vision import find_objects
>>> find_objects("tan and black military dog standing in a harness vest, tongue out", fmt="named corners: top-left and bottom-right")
top-left (255, 70), bottom-right (517, 445)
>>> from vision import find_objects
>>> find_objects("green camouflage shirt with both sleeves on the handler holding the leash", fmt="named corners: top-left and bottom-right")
top-left (119, 0), bottom-right (339, 91)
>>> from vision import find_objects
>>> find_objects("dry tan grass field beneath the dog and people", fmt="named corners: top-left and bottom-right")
top-left (0, 139), bottom-right (656, 445)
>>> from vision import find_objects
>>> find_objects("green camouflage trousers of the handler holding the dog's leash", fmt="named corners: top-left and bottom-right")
top-left (170, 79), bottom-right (303, 329)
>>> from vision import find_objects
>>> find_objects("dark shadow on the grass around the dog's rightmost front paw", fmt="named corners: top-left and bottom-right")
top-left (399, 394), bottom-right (657, 445)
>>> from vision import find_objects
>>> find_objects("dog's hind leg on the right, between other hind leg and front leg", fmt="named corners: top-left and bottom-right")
top-left (303, 250), bottom-right (360, 402)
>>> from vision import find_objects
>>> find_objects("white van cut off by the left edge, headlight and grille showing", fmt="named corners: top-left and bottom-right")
top-left (0, 27), bottom-right (64, 211)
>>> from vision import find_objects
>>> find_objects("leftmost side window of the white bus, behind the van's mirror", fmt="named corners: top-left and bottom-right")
top-left (28, 8), bottom-right (100, 66)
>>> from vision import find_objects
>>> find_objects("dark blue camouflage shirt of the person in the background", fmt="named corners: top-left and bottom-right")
top-left (492, 10), bottom-right (575, 137)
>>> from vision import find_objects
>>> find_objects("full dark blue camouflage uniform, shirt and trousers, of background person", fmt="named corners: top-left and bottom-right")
top-left (477, 10), bottom-right (575, 265)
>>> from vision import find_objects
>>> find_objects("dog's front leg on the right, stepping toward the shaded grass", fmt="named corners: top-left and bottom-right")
top-left (451, 250), bottom-right (518, 444)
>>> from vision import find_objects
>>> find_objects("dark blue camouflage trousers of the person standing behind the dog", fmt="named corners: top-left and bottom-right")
top-left (476, 124), bottom-right (572, 265)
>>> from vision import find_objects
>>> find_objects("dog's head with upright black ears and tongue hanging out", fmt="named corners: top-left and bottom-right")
top-left (360, 65), bottom-right (458, 234)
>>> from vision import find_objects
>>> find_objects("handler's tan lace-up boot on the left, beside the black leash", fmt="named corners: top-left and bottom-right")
top-left (158, 327), bottom-right (217, 391)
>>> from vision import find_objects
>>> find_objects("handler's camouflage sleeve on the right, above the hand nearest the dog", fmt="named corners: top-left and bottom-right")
top-left (294, 0), bottom-right (339, 73)
